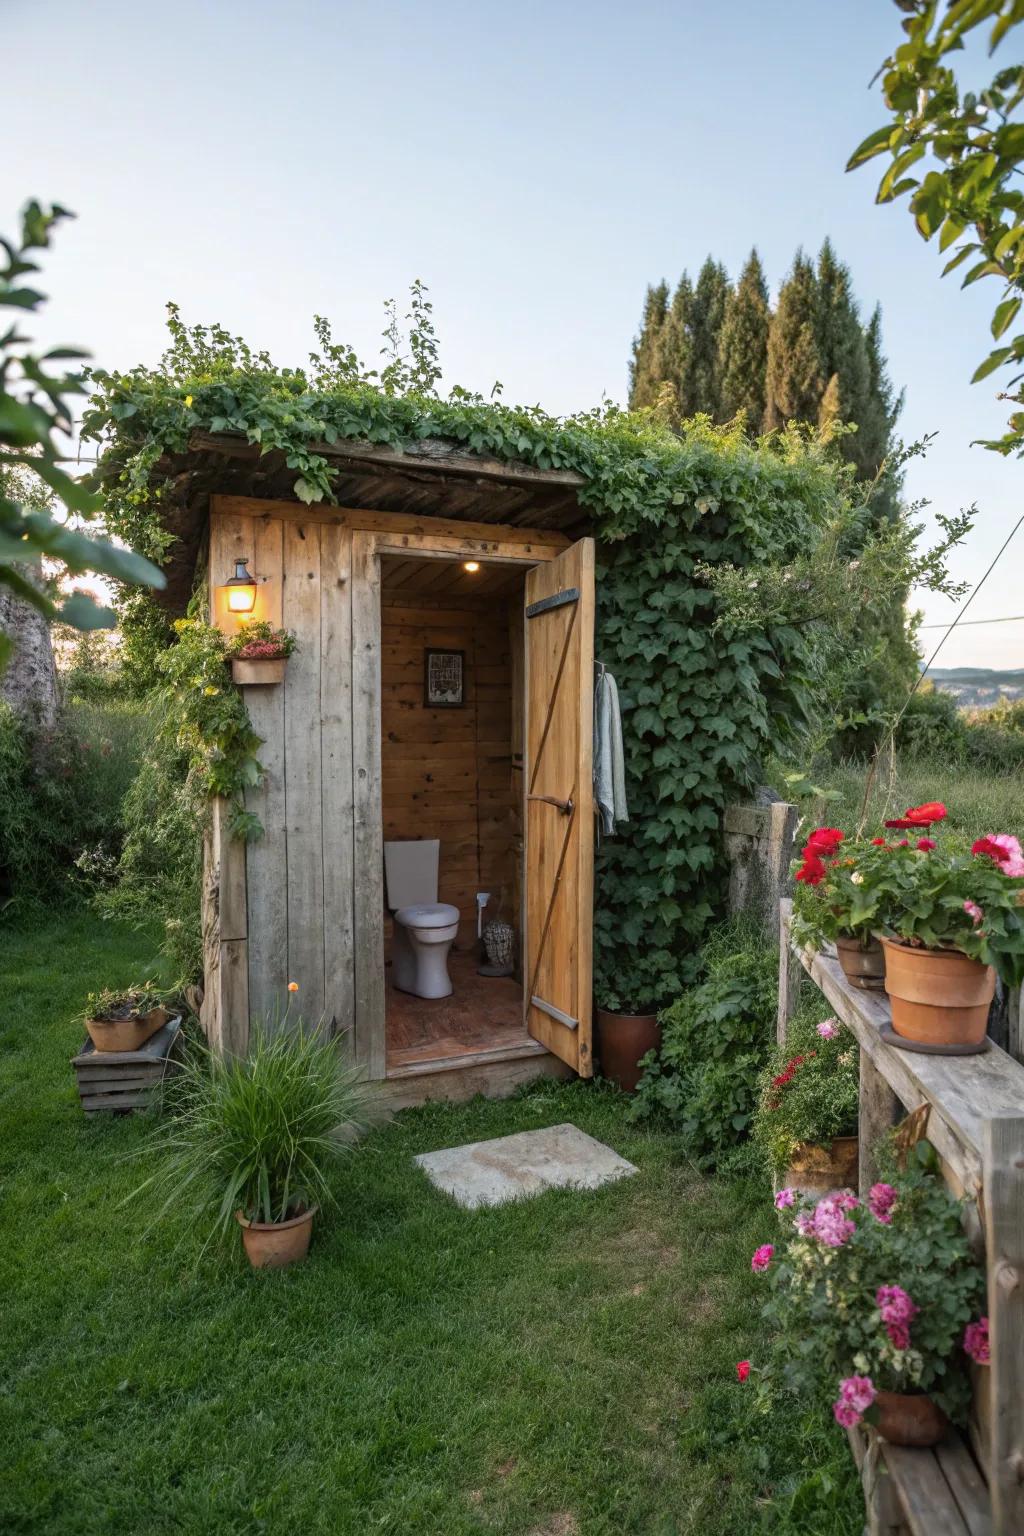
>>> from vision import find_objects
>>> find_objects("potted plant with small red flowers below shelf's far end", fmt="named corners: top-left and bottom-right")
top-left (754, 1018), bottom-right (860, 1195)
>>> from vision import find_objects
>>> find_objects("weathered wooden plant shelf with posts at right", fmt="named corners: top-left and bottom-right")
top-left (778, 900), bottom-right (1024, 1536)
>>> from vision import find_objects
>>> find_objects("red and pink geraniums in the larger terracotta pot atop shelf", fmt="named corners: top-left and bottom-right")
top-left (852, 802), bottom-right (1024, 1051)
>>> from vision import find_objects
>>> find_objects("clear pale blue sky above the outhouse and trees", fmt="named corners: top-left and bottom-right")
top-left (8, 0), bottom-right (1024, 667)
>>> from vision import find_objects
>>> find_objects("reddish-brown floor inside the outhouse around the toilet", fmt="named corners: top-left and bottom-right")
top-left (380, 945), bottom-right (543, 1077)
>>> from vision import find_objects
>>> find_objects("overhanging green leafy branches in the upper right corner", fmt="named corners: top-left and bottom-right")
top-left (846, 0), bottom-right (1024, 456)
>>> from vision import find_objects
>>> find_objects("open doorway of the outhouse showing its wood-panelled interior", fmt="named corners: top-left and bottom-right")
top-left (381, 556), bottom-right (543, 1077)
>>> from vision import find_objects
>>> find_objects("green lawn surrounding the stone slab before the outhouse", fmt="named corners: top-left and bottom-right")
top-left (0, 915), bottom-right (861, 1536)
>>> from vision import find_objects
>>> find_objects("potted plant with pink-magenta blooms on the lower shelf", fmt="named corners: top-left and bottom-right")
top-left (751, 1143), bottom-right (989, 1445)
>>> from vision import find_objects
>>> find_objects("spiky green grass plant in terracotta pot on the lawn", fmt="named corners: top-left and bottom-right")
top-left (135, 1012), bottom-right (368, 1269)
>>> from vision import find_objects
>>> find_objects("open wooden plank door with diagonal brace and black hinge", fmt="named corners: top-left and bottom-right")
top-left (524, 539), bottom-right (594, 1077)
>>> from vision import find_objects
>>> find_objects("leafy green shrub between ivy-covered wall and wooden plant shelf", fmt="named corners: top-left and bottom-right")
top-left (631, 923), bottom-right (778, 1167)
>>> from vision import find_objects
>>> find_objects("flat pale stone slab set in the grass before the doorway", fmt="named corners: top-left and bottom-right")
top-left (415, 1124), bottom-right (637, 1210)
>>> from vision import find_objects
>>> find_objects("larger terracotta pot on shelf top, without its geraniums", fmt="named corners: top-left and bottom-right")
top-left (883, 938), bottom-right (995, 1046)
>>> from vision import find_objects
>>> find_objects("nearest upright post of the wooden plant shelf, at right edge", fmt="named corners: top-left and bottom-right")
top-left (984, 1117), bottom-right (1024, 1536)
